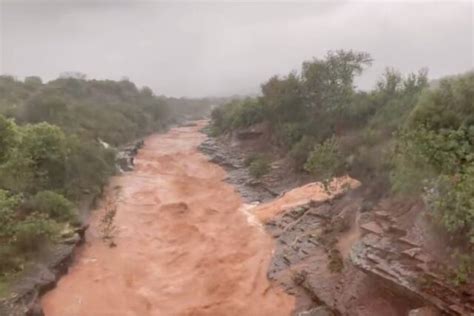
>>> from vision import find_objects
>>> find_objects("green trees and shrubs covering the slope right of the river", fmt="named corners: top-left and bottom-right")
top-left (212, 51), bottom-right (474, 248)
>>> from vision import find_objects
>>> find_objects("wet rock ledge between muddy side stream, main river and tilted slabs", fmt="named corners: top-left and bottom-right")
top-left (266, 190), bottom-right (419, 315)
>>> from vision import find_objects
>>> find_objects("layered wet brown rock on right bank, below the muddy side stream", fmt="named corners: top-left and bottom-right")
top-left (265, 190), bottom-right (474, 316)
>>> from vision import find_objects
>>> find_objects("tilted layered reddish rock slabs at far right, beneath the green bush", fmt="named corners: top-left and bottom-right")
top-left (351, 203), bottom-right (474, 315)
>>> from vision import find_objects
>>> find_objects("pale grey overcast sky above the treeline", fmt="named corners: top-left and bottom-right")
top-left (0, 0), bottom-right (474, 96)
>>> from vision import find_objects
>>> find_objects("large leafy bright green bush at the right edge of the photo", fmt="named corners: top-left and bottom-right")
top-left (393, 73), bottom-right (474, 244)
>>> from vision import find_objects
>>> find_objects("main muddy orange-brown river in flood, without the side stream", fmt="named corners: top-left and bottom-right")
top-left (42, 122), bottom-right (294, 316)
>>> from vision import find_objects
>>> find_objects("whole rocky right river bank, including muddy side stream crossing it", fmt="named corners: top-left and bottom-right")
top-left (205, 126), bottom-right (474, 316)
